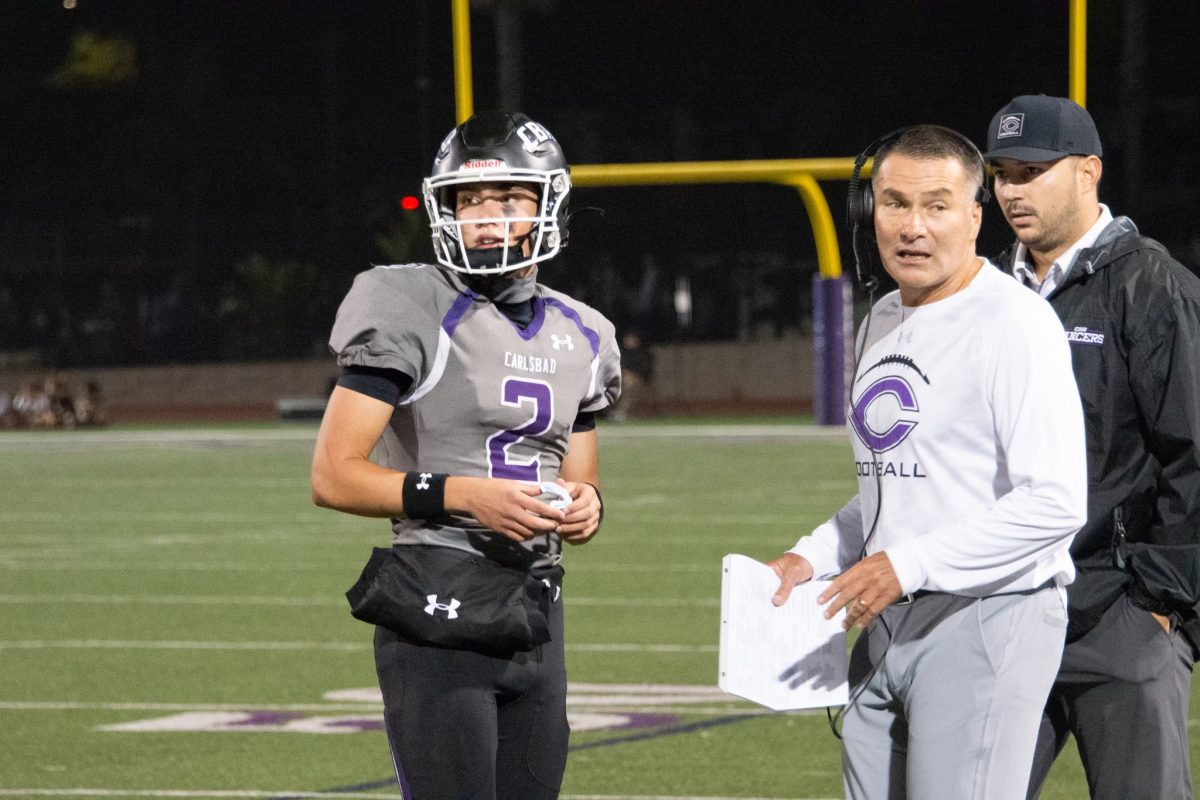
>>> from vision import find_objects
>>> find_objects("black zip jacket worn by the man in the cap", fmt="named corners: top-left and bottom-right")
top-left (996, 217), bottom-right (1200, 652)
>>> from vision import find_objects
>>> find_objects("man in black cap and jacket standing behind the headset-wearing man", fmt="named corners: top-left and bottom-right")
top-left (985, 95), bottom-right (1200, 800)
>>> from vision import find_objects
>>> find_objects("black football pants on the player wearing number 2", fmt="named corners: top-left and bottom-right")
top-left (374, 592), bottom-right (570, 800)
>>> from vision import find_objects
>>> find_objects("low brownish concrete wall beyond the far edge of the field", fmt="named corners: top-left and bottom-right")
top-left (0, 338), bottom-right (812, 421)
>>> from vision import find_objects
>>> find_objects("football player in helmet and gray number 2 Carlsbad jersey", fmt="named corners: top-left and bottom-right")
top-left (312, 112), bottom-right (620, 800)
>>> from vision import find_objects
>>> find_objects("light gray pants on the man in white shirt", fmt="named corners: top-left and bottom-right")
top-left (842, 587), bottom-right (1067, 800)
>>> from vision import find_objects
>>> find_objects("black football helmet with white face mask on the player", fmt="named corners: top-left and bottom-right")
top-left (421, 112), bottom-right (571, 275)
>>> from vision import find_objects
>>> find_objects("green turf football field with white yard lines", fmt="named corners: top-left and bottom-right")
top-left (0, 423), bottom-right (1166, 800)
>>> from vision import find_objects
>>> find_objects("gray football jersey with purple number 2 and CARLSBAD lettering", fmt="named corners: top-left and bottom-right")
top-left (330, 264), bottom-right (620, 558)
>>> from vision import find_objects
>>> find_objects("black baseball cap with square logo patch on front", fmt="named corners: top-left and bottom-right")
top-left (984, 95), bottom-right (1104, 163)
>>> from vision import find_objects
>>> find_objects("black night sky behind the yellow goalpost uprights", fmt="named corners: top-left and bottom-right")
top-left (0, 0), bottom-right (1200, 356)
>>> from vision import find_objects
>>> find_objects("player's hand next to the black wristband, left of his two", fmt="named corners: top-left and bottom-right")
top-left (445, 476), bottom-right (566, 542)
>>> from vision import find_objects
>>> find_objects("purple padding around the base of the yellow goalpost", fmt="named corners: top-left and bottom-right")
top-left (812, 273), bottom-right (854, 425)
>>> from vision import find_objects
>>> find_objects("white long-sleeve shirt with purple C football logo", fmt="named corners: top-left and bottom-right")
top-left (791, 261), bottom-right (1087, 596)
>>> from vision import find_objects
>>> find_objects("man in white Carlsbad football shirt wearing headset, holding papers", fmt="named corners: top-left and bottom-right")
top-left (770, 126), bottom-right (1086, 800)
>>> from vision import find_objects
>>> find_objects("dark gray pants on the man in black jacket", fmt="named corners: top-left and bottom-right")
top-left (1030, 597), bottom-right (1193, 800)
